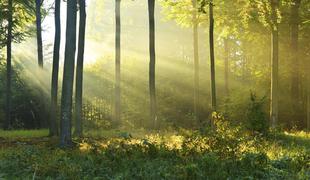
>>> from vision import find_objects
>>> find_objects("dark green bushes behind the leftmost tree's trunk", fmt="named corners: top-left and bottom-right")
top-left (0, 64), bottom-right (46, 129)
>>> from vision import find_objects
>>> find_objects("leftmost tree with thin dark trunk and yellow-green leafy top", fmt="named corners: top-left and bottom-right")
top-left (0, 0), bottom-right (34, 129)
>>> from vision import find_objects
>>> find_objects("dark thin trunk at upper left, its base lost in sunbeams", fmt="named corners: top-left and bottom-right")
top-left (36, 0), bottom-right (43, 68)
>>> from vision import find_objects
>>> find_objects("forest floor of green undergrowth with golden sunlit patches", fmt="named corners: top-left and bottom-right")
top-left (0, 129), bottom-right (310, 179)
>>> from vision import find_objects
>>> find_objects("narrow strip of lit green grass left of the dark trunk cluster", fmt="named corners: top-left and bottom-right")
top-left (0, 129), bottom-right (48, 139)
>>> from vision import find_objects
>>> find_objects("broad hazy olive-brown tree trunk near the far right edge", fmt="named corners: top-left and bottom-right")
top-left (290, 0), bottom-right (302, 126)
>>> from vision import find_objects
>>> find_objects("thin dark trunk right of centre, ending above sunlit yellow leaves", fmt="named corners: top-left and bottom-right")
top-left (209, 0), bottom-right (216, 111)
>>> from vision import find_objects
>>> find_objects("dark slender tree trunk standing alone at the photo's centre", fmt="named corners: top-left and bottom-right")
top-left (148, 0), bottom-right (158, 129)
